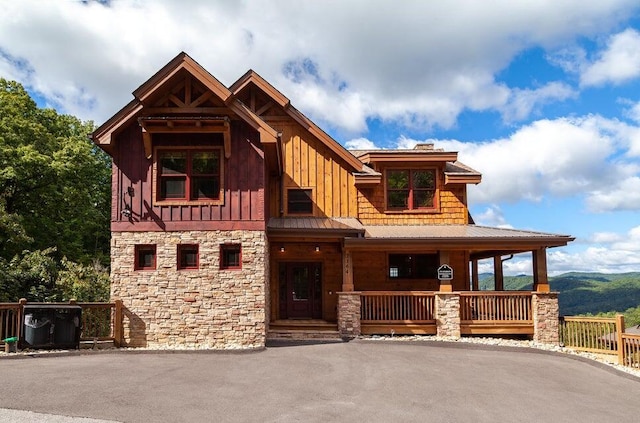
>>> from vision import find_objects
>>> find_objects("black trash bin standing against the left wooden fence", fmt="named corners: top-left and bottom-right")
top-left (22, 304), bottom-right (82, 349)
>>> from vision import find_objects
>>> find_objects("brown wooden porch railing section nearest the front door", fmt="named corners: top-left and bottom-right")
top-left (360, 291), bottom-right (436, 334)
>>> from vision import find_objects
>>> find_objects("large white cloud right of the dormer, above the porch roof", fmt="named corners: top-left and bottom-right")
top-left (424, 116), bottom-right (640, 211)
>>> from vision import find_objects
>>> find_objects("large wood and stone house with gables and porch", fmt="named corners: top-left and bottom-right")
top-left (92, 53), bottom-right (573, 348)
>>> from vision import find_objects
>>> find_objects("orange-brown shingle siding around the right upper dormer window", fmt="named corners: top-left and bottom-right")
top-left (358, 165), bottom-right (469, 225)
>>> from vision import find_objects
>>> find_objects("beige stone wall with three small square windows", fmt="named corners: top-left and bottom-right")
top-left (111, 230), bottom-right (269, 349)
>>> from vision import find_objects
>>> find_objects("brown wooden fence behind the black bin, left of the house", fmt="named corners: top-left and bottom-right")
top-left (0, 300), bottom-right (122, 347)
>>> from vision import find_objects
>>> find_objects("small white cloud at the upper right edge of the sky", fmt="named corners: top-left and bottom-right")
top-left (580, 29), bottom-right (640, 86)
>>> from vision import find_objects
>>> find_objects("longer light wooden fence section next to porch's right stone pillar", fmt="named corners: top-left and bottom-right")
top-left (559, 316), bottom-right (624, 354)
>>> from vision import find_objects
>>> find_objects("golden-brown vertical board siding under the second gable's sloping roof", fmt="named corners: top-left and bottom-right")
top-left (269, 120), bottom-right (358, 217)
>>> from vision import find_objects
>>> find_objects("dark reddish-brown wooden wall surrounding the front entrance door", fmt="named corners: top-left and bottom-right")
top-left (269, 242), bottom-right (342, 322)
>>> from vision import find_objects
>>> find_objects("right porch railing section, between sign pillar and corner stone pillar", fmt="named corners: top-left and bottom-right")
top-left (460, 291), bottom-right (533, 335)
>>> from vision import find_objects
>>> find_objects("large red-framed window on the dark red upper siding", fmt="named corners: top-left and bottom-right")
top-left (157, 148), bottom-right (222, 201)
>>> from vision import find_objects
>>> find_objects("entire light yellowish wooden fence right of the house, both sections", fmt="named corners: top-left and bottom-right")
top-left (559, 314), bottom-right (640, 368)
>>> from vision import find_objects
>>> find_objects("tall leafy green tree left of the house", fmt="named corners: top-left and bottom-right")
top-left (0, 78), bottom-right (111, 264)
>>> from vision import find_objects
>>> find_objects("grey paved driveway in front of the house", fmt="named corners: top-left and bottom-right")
top-left (0, 341), bottom-right (640, 423)
